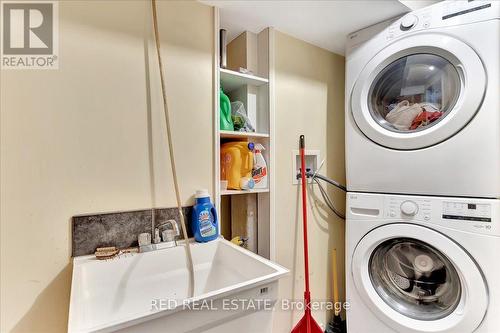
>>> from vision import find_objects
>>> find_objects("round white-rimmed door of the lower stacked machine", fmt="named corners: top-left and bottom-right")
top-left (351, 223), bottom-right (488, 333)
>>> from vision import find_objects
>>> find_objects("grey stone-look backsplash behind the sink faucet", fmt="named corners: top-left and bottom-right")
top-left (71, 207), bottom-right (193, 257)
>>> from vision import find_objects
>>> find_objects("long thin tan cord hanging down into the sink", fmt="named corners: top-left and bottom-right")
top-left (151, 0), bottom-right (194, 297)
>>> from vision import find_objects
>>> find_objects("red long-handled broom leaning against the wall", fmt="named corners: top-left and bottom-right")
top-left (292, 135), bottom-right (323, 333)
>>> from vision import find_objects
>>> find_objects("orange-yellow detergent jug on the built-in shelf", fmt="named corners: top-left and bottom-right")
top-left (220, 141), bottom-right (253, 190)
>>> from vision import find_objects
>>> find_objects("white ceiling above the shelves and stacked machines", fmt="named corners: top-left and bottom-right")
top-left (200, 0), bottom-right (418, 54)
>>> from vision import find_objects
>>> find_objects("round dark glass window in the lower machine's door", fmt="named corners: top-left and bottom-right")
top-left (368, 238), bottom-right (462, 320)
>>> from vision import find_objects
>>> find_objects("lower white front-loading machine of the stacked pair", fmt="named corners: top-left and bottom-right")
top-left (346, 193), bottom-right (500, 333)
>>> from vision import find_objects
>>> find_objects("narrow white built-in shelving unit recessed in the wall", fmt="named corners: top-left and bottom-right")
top-left (213, 8), bottom-right (275, 259)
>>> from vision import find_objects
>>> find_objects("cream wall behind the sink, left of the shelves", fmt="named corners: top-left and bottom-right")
top-left (0, 1), bottom-right (214, 333)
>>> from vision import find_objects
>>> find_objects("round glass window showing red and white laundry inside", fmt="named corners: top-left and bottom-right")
top-left (368, 54), bottom-right (460, 132)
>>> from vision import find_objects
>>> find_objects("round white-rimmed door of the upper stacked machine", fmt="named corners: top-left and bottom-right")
top-left (351, 34), bottom-right (486, 150)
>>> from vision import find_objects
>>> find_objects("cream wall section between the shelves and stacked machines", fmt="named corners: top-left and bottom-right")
top-left (273, 32), bottom-right (345, 332)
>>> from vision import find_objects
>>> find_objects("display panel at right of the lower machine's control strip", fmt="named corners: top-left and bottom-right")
top-left (442, 201), bottom-right (491, 222)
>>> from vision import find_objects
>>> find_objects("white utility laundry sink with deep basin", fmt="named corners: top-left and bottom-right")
top-left (68, 239), bottom-right (288, 332)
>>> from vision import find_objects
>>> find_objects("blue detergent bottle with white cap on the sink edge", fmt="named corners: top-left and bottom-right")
top-left (191, 190), bottom-right (219, 243)
